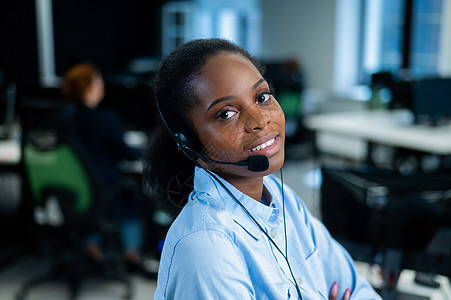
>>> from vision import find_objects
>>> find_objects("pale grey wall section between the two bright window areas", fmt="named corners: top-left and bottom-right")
top-left (261, 0), bottom-right (336, 91)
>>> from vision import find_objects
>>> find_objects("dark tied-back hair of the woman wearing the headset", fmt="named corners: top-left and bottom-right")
top-left (144, 39), bottom-right (264, 212)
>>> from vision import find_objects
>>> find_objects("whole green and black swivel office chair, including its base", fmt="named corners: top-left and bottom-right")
top-left (17, 102), bottom-right (133, 299)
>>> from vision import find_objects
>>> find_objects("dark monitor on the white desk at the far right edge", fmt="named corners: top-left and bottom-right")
top-left (413, 78), bottom-right (451, 125)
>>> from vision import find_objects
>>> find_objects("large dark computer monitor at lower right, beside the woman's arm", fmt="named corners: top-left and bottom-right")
top-left (321, 167), bottom-right (451, 276)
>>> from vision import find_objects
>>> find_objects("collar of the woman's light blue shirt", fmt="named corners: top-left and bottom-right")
top-left (194, 167), bottom-right (280, 239)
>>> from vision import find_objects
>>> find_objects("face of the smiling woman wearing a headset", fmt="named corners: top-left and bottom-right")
top-left (190, 52), bottom-right (285, 178)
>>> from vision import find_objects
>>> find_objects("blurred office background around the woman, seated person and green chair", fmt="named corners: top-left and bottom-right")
top-left (0, 0), bottom-right (451, 299)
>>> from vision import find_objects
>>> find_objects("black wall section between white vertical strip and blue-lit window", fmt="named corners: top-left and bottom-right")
top-left (53, 0), bottom-right (165, 76)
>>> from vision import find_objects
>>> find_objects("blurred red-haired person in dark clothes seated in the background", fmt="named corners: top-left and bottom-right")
top-left (63, 63), bottom-right (151, 275)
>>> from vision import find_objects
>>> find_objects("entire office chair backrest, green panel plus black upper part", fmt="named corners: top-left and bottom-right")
top-left (22, 102), bottom-right (103, 231)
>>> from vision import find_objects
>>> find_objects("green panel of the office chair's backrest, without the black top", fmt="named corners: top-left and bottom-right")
top-left (23, 130), bottom-right (102, 230)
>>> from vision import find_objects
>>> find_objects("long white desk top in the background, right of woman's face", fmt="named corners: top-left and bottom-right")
top-left (304, 110), bottom-right (451, 155)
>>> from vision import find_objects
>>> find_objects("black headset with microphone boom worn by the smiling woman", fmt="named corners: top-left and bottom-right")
top-left (155, 96), bottom-right (269, 172)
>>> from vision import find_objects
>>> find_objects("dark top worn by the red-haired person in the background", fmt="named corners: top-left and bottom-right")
top-left (74, 105), bottom-right (141, 184)
